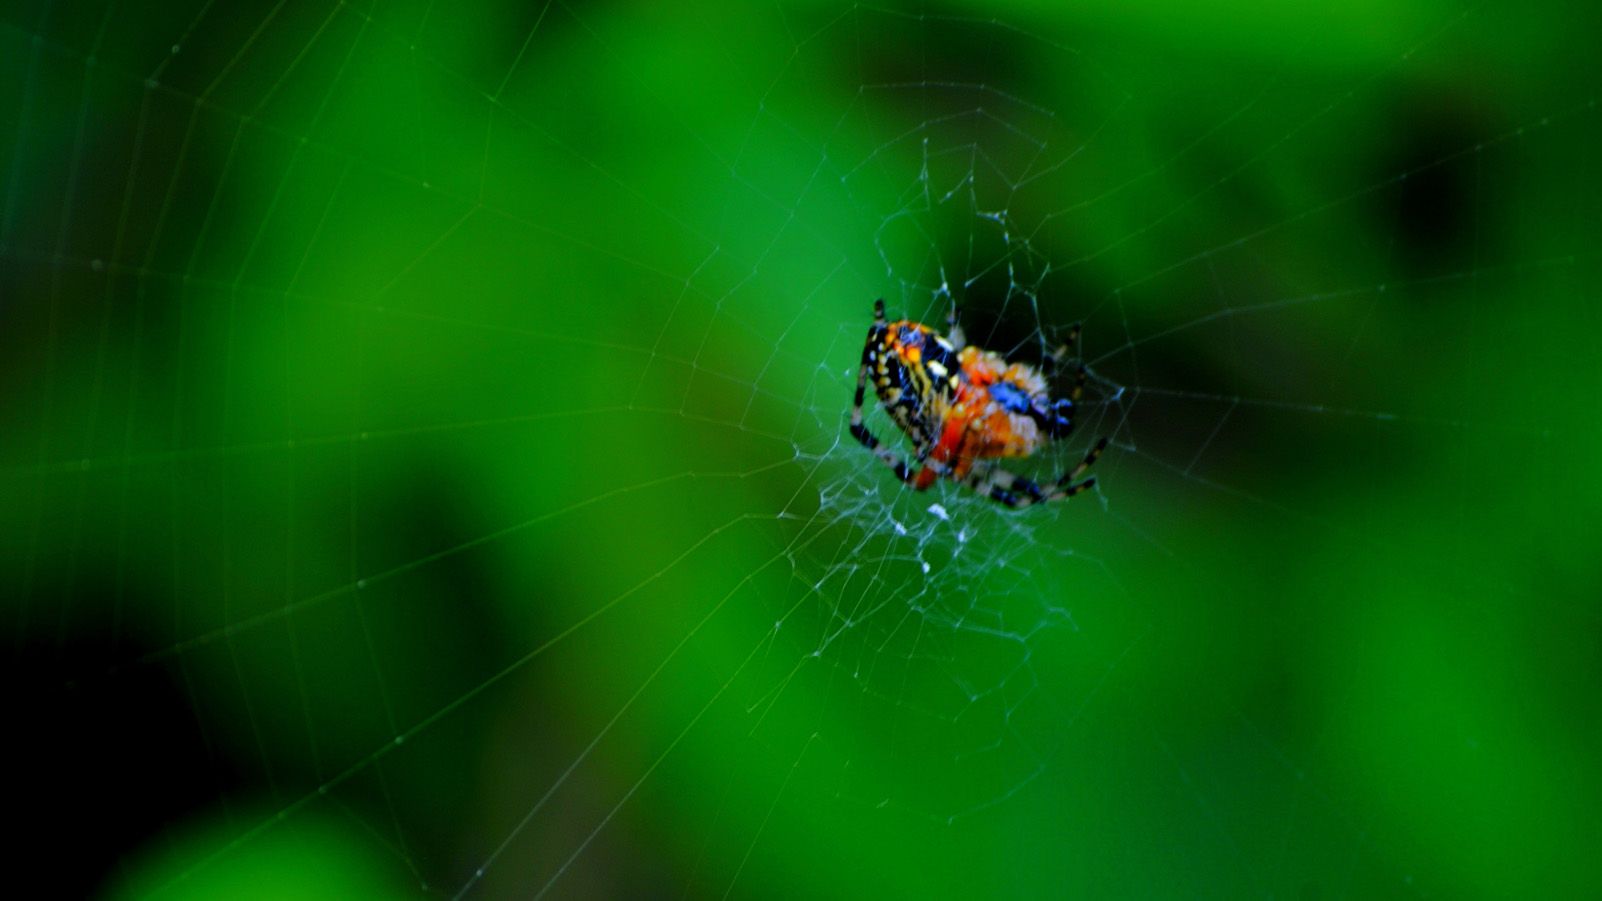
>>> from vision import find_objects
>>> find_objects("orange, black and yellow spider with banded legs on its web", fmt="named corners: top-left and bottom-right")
top-left (851, 298), bottom-right (1107, 508)
